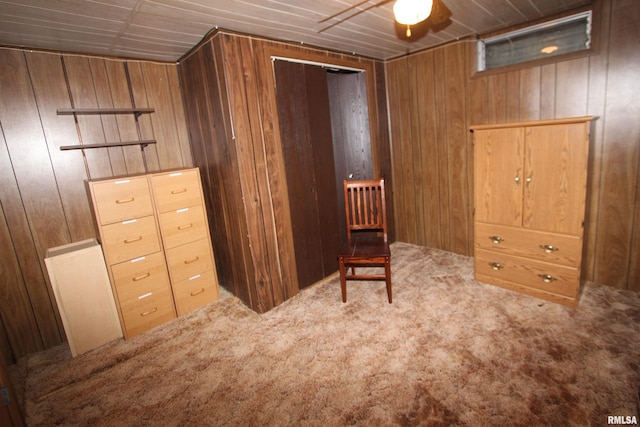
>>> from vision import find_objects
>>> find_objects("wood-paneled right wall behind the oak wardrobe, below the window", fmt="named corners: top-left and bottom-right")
top-left (386, 0), bottom-right (640, 291)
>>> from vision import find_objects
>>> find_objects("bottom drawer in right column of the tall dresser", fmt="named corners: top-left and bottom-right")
top-left (173, 270), bottom-right (218, 316)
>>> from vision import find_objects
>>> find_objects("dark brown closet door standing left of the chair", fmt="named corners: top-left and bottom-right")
top-left (274, 61), bottom-right (340, 288)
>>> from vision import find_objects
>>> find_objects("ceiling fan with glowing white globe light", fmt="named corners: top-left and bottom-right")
top-left (318, 0), bottom-right (451, 38)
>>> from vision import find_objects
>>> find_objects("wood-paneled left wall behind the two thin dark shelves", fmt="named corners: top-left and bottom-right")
top-left (0, 49), bottom-right (193, 362)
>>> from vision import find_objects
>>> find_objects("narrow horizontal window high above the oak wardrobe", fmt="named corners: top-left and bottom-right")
top-left (478, 11), bottom-right (591, 71)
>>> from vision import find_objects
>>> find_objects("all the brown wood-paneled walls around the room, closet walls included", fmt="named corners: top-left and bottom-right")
top-left (0, 0), bottom-right (640, 368)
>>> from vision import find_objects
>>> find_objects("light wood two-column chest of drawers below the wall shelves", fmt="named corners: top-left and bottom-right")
top-left (88, 168), bottom-right (218, 338)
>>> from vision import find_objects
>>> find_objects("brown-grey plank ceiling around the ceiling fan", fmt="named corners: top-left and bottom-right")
top-left (0, 0), bottom-right (590, 62)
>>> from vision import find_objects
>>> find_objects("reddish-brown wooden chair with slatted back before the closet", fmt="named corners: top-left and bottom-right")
top-left (338, 179), bottom-right (392, 304)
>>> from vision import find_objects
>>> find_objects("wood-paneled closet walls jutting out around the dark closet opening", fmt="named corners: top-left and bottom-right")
top-left (179, 32), bottom-right (391, 312)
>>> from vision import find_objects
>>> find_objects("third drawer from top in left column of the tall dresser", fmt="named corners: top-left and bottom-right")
top-left (111, 252), bottom-right (169, 301)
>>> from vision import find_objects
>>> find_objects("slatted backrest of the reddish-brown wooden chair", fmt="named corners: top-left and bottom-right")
top-left (344, 178), bottom-right (387, 240)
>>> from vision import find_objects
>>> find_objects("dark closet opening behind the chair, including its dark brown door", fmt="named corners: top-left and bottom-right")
top-left (274, 60), bottom-right (373, 289)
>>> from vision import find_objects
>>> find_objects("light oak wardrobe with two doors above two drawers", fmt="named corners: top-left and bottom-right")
top-left (471, 117), bottom-right (593, 307)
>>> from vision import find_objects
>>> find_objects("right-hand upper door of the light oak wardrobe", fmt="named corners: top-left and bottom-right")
top-left (523, 123), bottom-right (589, 235)
